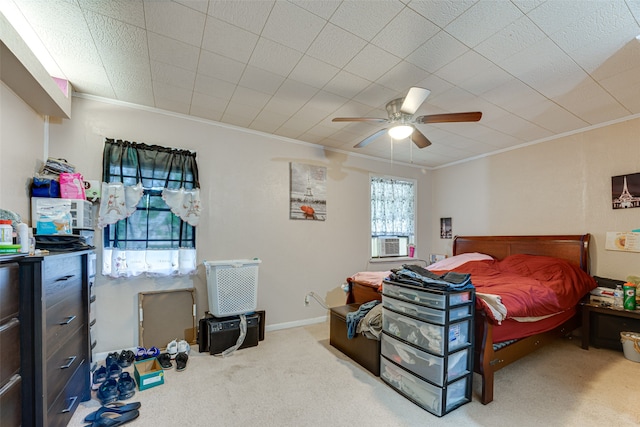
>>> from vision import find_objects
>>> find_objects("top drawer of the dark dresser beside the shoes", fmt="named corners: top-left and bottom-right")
top-left (43, 256), bottom-right (82, 308)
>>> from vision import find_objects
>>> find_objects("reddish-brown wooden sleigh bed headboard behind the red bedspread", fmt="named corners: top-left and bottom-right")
top-left (453, 234), bottom-right (590, 273)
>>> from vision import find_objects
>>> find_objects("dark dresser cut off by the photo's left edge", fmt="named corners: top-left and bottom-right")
top-left (0, 256), bottom-right (22, 427)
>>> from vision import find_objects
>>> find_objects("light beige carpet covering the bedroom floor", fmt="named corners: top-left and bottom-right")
top-left (69, 323), bottom-right (640, 427)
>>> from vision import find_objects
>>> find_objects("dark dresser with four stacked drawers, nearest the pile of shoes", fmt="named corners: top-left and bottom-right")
top-left (19, 251), bottom-right (93, 427)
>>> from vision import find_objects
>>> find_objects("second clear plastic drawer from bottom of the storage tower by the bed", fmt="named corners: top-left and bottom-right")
top-left (380, 334), bottom-right (470, 386)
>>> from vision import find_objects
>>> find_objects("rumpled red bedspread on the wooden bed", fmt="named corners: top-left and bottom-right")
top-left (434, 254), bottom-right (596, 321)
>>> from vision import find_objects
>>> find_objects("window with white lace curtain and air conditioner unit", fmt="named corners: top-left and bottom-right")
top-left (370, 176), bottom-right (416, 258)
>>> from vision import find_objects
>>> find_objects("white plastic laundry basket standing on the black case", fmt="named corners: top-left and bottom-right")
top-left (204, 259), bottom-right (262, 317)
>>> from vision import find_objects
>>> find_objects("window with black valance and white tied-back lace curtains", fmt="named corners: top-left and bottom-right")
top-left (99, 139), bottom-right (200, 277)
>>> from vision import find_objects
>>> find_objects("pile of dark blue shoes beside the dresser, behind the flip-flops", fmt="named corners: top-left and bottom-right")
top-left (92, 350), bottom-right (136, 405)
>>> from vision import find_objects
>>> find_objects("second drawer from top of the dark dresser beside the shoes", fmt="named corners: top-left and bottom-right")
top-left (45, 282), bottom-right (87, 355)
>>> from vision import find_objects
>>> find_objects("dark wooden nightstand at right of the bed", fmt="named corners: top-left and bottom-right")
top-left (580, 301), bottom-right (640, 351)
